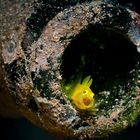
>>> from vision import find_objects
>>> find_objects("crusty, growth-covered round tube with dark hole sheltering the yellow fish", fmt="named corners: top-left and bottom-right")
top-left (0, 0), bottom-right (140, 139)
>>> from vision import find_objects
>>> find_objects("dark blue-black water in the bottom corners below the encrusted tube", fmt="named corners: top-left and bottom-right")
top-left (0, 118), bottom-right (140, 140)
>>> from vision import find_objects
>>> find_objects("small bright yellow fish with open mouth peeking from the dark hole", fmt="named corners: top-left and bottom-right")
top-left (63, 76), bottom-right (94, 110)
